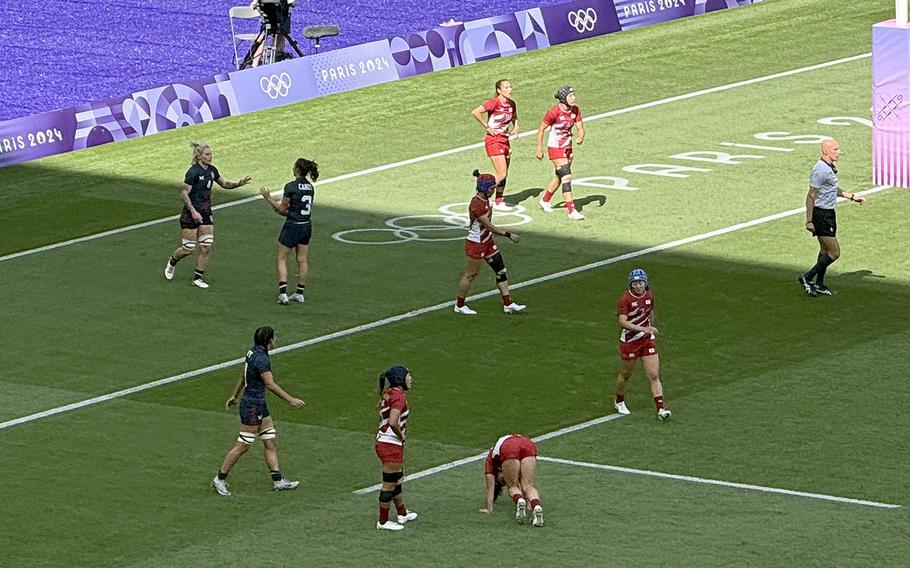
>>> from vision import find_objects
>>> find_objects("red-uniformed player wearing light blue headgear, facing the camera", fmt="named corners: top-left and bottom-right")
top-left (613, 268), bottom-right (671, 422)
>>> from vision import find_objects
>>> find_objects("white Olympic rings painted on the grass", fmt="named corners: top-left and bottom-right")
top-left (332, 203), bottom-right (532, 245)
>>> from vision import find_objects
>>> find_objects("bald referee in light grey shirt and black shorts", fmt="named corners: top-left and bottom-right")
top-left (797, 138), bottom-right (866, 296)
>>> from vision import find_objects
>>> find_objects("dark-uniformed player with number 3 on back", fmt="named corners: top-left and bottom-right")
top-left (259, 158), bottom-right (319, 305)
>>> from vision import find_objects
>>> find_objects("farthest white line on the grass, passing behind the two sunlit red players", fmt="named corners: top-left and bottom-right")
top-left (0, 52), bottom-right (872, 262)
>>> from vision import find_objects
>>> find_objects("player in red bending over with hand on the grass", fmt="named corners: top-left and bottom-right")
top-left (480, 434), bottom-right (543, 527)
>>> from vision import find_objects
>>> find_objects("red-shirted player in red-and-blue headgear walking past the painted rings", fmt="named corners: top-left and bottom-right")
top-left (455, 170), bottom-right (527, 316)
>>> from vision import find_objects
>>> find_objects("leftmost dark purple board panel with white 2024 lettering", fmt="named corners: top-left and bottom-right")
top-left (0, 109), bottom-right (76, 166)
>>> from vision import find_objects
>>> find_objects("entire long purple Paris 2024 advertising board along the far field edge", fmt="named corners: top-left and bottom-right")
top-left (0, 0), bottom-right (760, 166)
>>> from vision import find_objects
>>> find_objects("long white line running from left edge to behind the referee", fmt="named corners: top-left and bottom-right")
top-left (0, 185), bottom-right (890, 430)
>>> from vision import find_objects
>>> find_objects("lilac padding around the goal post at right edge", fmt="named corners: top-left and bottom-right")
top-left (872, 20), bottom-right (910, 187)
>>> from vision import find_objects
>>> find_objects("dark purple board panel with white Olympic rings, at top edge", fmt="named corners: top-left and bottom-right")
top-left (540, 0), bottom-right (621, 45)
